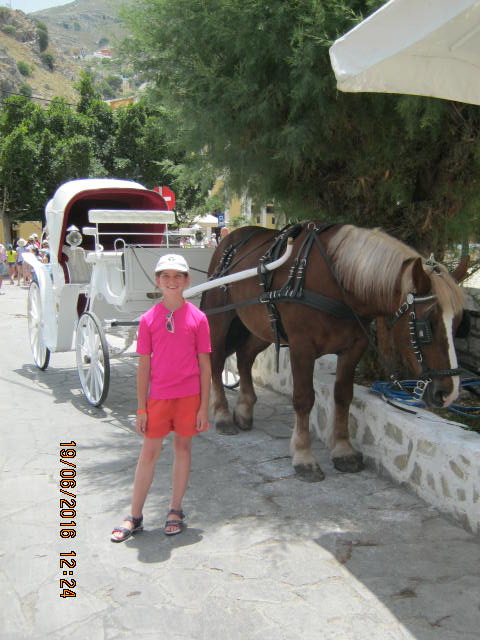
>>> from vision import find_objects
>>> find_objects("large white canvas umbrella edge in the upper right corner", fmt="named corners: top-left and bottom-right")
top-left (330, 0), bottom-right (480, 104)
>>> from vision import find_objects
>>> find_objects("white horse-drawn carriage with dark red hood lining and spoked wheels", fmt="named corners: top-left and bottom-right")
top-left (25, 178), bottom-right (291, 406)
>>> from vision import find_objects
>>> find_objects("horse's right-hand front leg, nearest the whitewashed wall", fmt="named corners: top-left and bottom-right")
top-left (331, 340), bottom-right (365, 473)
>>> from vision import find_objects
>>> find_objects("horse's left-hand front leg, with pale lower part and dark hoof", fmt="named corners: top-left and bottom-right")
top-left (290, 345), bottom-right (325, 482)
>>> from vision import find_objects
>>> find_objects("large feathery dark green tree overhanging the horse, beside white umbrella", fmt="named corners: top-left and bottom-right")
top-left (121, 0), bottom-right (480, 255)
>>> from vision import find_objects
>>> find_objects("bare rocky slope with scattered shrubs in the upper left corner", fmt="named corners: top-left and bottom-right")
top-left (0, 7), bottom-right (79, 103)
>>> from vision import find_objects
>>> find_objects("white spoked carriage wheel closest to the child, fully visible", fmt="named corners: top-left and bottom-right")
top-left (75, 311), bottom-right (110, 407)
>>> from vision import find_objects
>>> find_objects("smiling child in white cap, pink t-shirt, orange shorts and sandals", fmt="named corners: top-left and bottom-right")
top-left (110, 253), bottom-right (211, 542)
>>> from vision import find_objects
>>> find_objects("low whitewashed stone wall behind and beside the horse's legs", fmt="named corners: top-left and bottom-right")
top-left (254, 344), bottom-right (480, 534)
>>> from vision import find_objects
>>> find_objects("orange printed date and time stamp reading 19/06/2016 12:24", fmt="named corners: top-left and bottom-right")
top-left (59, 441), bottom-right (77, 598)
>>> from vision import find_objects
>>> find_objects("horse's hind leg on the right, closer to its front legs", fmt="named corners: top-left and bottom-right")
top-left (233, 334), bottom-right (270, 431)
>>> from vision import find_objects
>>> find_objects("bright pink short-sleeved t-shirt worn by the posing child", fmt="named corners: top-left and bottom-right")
top-left (137, 302), bottom-right (212, 400)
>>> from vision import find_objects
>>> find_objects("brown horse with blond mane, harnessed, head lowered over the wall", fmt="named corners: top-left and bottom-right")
top-left (202, 221), bottom-right (467, 481)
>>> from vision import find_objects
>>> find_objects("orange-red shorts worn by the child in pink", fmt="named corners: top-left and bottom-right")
top-left (145, 394), bottom-right (208, 438)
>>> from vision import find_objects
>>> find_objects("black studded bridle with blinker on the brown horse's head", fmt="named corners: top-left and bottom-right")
top-left (389, 292), bottom-right (461, 400)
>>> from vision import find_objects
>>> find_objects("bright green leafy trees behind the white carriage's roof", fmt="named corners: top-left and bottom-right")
top-left (0, 74), bottom-right (214, 228)
